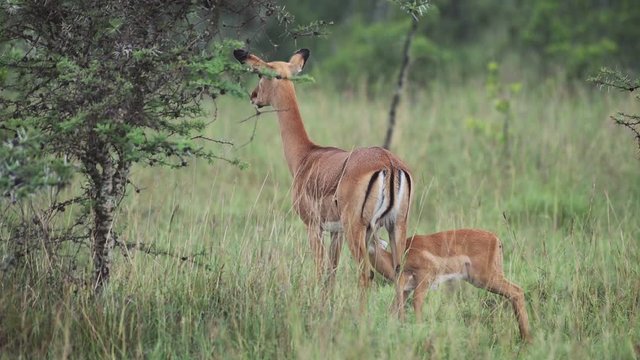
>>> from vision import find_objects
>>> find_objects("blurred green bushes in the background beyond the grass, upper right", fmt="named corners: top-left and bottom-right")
top-left (272, 0), bottom-right (640, 88)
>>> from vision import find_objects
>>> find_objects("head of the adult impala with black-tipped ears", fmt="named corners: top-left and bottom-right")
top-left (233, 49), bottom-right (309, 107)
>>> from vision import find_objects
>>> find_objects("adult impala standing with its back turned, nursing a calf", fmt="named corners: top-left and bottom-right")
top-left (233, 49), bottom-right (412, 316)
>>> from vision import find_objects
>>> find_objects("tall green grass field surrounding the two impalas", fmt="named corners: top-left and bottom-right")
top-left (0, 82), bottom-right (640, 359)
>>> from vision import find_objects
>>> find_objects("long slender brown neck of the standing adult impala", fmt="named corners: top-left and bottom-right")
top-left (273, 81), bottom-right (314, 174)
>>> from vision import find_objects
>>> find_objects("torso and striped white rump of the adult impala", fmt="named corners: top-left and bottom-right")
top-left (293, 147), bottom-right (412, 236)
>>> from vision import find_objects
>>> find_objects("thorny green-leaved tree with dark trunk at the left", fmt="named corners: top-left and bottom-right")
top-left (0, 0), bottom-right (272, 290)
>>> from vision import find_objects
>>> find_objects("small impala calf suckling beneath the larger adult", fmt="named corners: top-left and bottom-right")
top-left (368, 229), bottom-right (530, 340)
